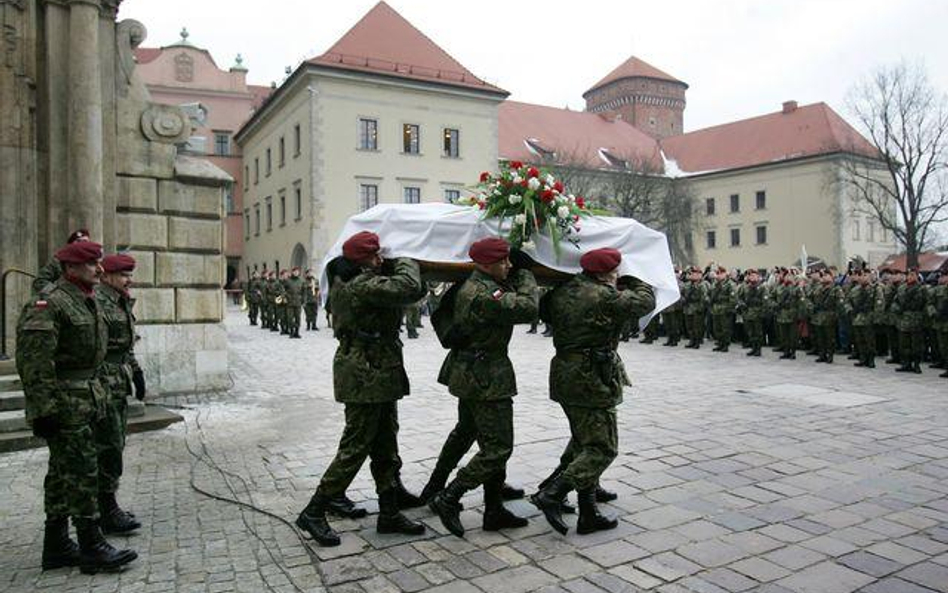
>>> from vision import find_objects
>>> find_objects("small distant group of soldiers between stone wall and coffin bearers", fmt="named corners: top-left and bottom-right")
top-left (243, 267), bottom-right (328, 339)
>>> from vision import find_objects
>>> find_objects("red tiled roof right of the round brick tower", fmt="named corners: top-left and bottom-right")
top-left (661, 102), bottom-right (878, 173)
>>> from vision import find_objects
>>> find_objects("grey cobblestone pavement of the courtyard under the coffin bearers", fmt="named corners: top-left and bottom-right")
top-left (0, 311), bottom-right (948, 593)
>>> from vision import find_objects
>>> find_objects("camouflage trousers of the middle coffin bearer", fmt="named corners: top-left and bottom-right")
top-left (456, 398), bottom-right (513, 490)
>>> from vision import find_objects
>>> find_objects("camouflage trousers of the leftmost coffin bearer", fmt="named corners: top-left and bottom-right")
top-left (318, 402), bottom-right (401, 498)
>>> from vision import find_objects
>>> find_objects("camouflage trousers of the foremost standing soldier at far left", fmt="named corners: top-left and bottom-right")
top-left (43, 423), bottom-right (99, 519)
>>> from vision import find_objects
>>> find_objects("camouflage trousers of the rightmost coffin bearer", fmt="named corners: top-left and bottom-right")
top-left (560, 404), bottom-right (619, 492)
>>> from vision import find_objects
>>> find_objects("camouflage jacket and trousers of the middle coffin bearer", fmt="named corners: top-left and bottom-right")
top-left (438, 270), bottom-right (537, 490)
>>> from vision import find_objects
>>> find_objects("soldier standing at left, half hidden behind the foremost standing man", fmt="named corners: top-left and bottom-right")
top-left (95, 253), bottom-right (145, 533)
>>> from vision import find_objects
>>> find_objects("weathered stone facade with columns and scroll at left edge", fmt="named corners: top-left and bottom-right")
top-left (0, 0), bottom-right (232, 392)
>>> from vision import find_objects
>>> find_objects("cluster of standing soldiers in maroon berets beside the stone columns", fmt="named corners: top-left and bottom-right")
top-left (16, 229), bottom-right (146, 573)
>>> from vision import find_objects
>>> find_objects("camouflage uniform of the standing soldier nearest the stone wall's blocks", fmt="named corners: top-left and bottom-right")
top-left (95, 284), bottom-right (141, 493)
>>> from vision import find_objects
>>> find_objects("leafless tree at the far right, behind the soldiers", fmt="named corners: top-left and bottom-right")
top-left (840, 63), bottom-right (948, 266)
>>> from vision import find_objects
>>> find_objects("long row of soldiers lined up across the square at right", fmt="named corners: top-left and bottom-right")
top-left (642, 263), bottom-right (948, 377)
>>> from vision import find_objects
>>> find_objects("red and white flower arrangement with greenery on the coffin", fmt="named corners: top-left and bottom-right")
top-left (457, 161), bottom-right (590, 255)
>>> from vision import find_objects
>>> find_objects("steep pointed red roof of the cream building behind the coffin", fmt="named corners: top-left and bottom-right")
top-left (308, 2), bottom-right (509, 95)
